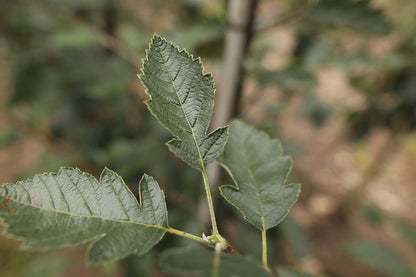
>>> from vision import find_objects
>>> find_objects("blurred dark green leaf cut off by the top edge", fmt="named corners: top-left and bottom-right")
top-left (308, 0), bottom-right (391, 34)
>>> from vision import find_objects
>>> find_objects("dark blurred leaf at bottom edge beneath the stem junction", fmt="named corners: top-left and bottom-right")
top-left (160, 247), bottom-right (270, 277)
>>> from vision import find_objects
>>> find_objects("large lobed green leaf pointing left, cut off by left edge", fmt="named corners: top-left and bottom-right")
top-left (0, 168), bottom-right (167, 264)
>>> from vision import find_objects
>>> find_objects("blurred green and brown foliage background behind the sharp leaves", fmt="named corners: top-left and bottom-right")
top-left (0, 0), bottom-right (416, 277)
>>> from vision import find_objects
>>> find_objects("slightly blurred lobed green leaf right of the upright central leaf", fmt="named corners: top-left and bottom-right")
top-left (218, 120), bottom-right (300, 230)
